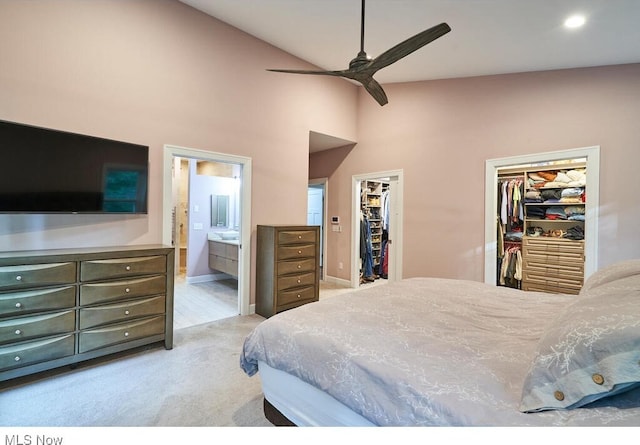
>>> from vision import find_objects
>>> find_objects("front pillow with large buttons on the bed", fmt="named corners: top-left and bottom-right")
top-left (520, 274), bottom-right (640, 412)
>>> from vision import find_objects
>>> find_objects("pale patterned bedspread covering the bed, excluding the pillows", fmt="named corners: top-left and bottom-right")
top-left (241, 278), bottom-right (640, 426)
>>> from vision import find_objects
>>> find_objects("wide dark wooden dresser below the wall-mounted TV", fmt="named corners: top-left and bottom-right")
top-left (0, 245), bottom-right (174, 381)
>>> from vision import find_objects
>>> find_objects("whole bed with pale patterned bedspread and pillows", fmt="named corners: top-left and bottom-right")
top-left (240, 260), bottom-right (640, 426)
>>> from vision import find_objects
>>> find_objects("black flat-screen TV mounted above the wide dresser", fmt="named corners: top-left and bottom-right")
top-left (0, 120), bottom-right (149, 213)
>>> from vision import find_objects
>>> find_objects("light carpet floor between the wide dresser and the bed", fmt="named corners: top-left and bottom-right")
top-left (0, 315), bottom-right (271, 427)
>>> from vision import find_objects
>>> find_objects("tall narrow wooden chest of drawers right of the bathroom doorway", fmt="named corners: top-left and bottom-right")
top-left (256, 225), bottom-right (320, 318)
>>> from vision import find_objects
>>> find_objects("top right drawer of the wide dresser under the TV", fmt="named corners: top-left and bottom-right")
top-left (80, 256), bottom-right (167, 281)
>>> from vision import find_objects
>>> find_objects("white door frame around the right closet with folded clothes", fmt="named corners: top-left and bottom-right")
top-left (484, 145), bottom-right (600, 284)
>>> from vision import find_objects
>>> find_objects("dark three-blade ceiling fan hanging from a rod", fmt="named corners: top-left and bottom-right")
top-left (267, 0), bottom-right (451, 105)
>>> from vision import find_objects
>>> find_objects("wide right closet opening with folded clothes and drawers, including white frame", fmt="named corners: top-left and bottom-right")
top-left (485, 147), bottom-right (599, 294)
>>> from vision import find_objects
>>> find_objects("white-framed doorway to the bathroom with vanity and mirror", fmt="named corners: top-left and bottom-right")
top-left (163, 146), bottom-right (250, 329)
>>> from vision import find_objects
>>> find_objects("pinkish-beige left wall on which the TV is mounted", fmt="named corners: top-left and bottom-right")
top-left (0, 0), bottom-right (357, 302)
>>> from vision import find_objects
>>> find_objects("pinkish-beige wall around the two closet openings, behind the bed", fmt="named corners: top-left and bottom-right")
top-left (310, 64), bottom-right (640, 281)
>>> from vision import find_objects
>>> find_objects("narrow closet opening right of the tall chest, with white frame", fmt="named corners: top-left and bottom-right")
top-left (351, 170), bottom-right (403, 287)
